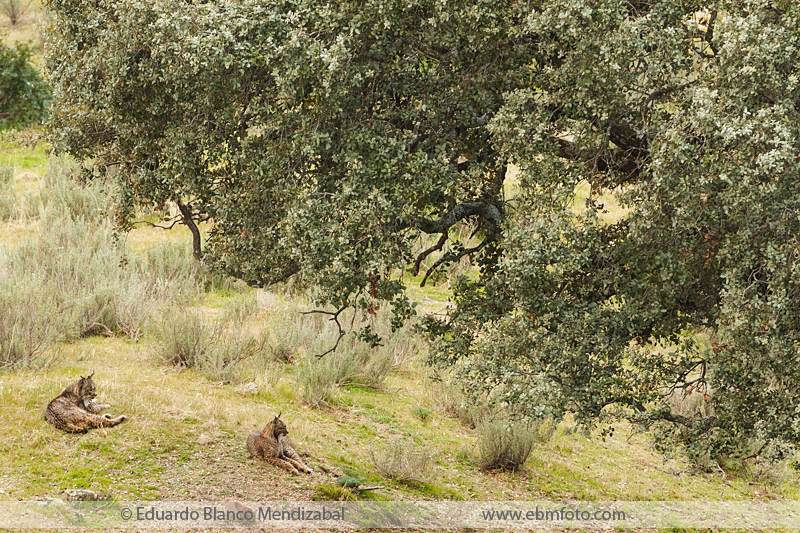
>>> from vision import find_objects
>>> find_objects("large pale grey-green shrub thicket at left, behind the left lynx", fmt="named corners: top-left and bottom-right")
top-left (0, 161), bottom-right (205, 368)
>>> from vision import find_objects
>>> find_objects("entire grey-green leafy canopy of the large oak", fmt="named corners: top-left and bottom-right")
top-left (45, 0), bottom-right (800, 459)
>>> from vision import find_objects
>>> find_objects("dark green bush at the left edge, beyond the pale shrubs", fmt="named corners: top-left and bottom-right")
top-left (0, 43), bottom-right (50, 131)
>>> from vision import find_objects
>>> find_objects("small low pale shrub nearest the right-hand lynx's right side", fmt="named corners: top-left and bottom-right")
top-left (370, 439), bottom-right (435, 483)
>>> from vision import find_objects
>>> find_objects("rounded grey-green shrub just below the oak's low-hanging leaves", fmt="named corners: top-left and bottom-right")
top-left (477, 417), bottom-right (553, 471)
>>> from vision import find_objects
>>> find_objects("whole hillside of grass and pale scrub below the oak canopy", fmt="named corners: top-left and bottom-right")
top-left (0, 140), bottom-right (798, 508)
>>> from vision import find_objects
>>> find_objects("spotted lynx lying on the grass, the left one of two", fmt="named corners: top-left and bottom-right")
top-left (44, 372), bottom-right (125, 433)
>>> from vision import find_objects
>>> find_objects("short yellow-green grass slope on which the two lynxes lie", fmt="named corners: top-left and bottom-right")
top-left (0, 138), bottom-right (798, 500)
